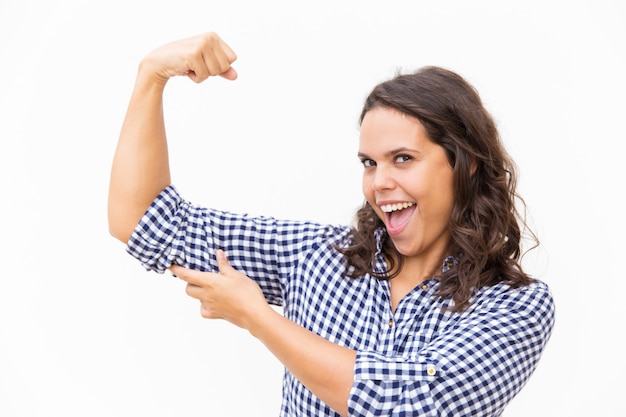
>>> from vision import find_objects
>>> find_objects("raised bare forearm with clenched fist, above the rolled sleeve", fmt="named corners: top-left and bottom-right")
top-left (108, 33), bottom-right (237, 243)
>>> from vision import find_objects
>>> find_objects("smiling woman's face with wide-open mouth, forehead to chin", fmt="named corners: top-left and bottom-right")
top-left (359, 107), bottom-right (454, 259)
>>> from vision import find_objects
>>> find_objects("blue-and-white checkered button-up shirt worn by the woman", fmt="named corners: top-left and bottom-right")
top-left (127, 186), bottom-right (554, 417)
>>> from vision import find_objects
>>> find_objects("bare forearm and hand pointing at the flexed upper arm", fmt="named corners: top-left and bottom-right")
top-left (170, 250), bottom-right (356, 416)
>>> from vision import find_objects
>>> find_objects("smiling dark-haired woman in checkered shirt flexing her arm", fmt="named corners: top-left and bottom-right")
top-left (109, 33), bottom-right (554, 417)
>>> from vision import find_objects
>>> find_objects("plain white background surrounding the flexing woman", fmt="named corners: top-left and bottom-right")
top-left (0, 0), bottom-right (626, 417)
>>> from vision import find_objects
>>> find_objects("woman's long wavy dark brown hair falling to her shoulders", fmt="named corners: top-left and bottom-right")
top-left (338, 67), bottom-right (539, 311)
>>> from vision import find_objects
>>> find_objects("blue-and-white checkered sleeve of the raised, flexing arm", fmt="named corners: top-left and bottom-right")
top-left (126, 185), bottom-right (342, 305)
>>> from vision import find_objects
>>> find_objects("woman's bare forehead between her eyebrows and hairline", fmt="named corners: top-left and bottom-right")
top-left (359, 107), bottom-right (435, 153)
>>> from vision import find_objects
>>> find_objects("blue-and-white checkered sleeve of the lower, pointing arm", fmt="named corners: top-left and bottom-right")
top-left (349, 282), bottom-right (554, 416)
